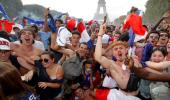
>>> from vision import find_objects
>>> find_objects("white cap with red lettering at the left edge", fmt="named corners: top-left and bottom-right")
top-left (0, 38), bottom-right (10, 50)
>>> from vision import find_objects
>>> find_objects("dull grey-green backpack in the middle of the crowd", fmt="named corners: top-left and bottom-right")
top-left (62, 55), bottom-right (85, 80)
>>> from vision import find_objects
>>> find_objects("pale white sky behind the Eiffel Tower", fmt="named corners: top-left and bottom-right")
top-left (22, 0), bottom-right (147, 21)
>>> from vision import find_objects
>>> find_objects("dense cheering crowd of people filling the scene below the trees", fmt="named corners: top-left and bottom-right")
top-left (0, 7), bottom-right (170, 100)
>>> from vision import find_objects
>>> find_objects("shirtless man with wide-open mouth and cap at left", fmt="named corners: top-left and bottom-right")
top-left (12, 27), bottom-right (42, 74)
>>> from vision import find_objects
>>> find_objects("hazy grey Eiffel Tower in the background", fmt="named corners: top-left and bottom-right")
top-left (93, 0), bottom-right (109, 23)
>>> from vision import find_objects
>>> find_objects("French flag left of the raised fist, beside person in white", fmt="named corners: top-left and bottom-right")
top-left (67, 19), bottom-right (93, 48)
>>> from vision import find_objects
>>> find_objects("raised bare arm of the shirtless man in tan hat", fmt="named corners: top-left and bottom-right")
top-left (94, 24), bottom-right (111, 68)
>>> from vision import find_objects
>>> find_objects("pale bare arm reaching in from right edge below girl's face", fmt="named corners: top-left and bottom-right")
top-left (145, 61), bottom-right (170, 70)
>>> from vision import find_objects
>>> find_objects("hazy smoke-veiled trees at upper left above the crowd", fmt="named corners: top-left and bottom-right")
top-left (0, 0), bottom-right (61, 19)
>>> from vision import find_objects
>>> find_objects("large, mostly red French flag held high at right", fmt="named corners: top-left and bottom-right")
top-left (123, 10), bottom-right (147, 56)
